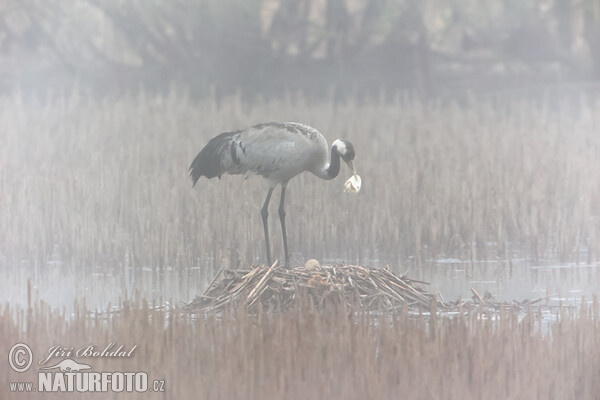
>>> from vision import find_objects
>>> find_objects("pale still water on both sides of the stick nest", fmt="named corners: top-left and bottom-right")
top-left (0, 253), bottom-right (600, 311)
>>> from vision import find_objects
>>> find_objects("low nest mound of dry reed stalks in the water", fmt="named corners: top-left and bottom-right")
top-left (184, 260), bottom-right (441, 312)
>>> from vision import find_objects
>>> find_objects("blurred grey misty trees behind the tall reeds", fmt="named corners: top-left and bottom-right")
top-left (0, 0), bottom-right (600, 99)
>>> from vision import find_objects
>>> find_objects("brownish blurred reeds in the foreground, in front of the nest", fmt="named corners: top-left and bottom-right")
top-left (0, 299), bottom-right (600, 399)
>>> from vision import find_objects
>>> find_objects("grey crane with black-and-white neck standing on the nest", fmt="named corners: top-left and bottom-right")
top-left (189, 122), bottom-right (356, 268)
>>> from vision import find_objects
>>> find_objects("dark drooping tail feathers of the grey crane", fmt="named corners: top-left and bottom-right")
top-left (189, 132), bottom-right (237, 187)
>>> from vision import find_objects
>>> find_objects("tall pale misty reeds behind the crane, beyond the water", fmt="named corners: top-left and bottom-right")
top-left (0, 92), bottom-right (600, 276)
